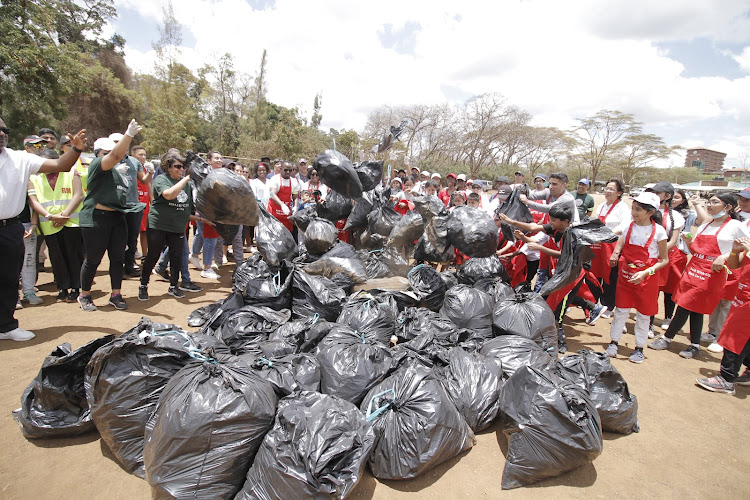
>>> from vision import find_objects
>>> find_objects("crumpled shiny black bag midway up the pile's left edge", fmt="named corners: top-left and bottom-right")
top-left (232, 253), bottom-right (292, 311)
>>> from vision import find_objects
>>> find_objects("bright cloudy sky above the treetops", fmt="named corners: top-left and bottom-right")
top-left (112, 0), bottom-right (750, 166)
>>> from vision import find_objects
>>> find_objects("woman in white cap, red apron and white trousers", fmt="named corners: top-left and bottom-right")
top-left (607, 193), bottom-right (669, 363)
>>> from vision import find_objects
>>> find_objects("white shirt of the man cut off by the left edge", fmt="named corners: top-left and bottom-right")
top-left (0, 148), bottom-right (47, 219)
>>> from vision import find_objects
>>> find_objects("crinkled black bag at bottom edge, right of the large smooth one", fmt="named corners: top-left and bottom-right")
top-left (235, 391), bottom-right (375, 500)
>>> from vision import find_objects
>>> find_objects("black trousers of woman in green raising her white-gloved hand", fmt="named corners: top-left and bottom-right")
top-left (81, 210), bottom-right (128, 292)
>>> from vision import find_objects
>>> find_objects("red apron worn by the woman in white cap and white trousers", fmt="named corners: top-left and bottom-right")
top-left (615, 221), bottom-right (659, 316)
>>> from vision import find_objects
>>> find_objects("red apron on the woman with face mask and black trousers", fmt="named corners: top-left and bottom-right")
top-left (673, 217), bottom-right (730, 314)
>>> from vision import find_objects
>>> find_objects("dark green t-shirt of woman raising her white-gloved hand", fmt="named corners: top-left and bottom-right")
top-left (79, 157), bottom-right (146, 227)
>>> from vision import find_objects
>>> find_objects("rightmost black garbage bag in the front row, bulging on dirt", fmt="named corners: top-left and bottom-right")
top-left (500, 366), bottom-right (602, 490)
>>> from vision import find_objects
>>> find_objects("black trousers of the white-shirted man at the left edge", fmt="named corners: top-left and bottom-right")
top-left (0, 219), bottom-right (24, 333)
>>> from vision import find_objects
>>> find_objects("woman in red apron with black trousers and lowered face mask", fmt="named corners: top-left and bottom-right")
top-left (648, 193), bottom-right (750, 359)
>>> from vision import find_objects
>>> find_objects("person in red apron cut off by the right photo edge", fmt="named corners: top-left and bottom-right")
top-left (697, 238), bottom-right (750, 394)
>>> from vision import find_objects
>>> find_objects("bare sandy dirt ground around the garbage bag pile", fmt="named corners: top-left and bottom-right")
top-left (0, 200), bottom-right (750, 499)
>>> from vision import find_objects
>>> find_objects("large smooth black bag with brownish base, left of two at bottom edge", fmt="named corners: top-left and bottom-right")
top-left (143, 356), bottom-right (277, 498)
